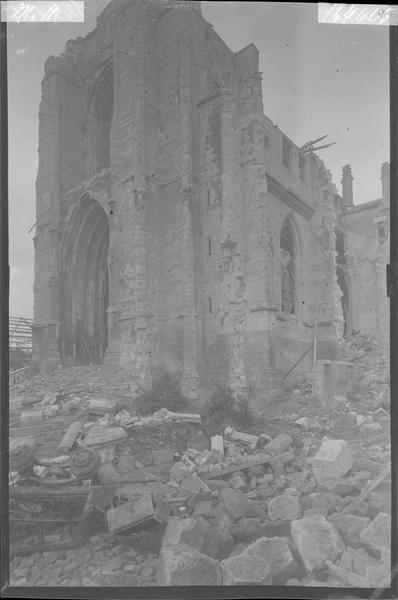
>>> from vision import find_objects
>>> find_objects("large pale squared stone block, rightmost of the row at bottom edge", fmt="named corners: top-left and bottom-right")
top-left (291, 515), bottom-right (344, 571)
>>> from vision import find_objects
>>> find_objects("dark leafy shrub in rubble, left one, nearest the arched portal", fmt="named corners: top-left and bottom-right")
top-left (135, 373), bottom-right (187, 415)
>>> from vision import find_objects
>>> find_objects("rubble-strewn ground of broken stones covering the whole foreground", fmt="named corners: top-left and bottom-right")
top-left (10, 340), bottom-right (391, 587)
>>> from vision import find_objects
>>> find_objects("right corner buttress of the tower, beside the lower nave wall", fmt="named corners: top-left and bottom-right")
top-left (235, 45), bottom-right (274, 393)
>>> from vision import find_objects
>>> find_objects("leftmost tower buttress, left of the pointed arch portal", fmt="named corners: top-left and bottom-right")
top-left (33, 43), bottom-right (88, 368)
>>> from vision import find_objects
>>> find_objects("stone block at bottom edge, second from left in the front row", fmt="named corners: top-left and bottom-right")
top-left (221, 552), bottom-right (272, 585)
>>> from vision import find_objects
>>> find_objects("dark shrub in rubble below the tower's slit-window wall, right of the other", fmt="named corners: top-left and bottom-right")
top-left (202, 384), bottom-right (254, 430)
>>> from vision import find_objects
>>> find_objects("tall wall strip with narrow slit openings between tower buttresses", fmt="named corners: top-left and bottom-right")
top-left (198, 26), bottom-right (247, 394)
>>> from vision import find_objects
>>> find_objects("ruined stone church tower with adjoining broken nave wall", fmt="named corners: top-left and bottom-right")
top-left (33, 0), bottom-right (390, 404)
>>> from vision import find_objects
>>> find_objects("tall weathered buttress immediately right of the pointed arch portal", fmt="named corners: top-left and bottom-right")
top-left (115, 3), bottom-right (157, 387)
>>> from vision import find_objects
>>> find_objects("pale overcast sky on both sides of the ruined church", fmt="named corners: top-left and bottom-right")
top-left (8, 0), bottom-right (389, 317)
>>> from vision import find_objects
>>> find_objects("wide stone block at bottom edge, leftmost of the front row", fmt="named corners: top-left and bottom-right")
top-left (157, 544), bottom-right (221, 586)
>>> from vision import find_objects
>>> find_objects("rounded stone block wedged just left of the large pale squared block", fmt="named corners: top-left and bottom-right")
top-left (244, 537), bottom-right (299, 585)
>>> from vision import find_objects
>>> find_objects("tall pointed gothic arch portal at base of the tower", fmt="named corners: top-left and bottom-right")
top-left (59, 196), bottom-right (109, 364)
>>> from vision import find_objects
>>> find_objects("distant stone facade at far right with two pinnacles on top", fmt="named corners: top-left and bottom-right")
top-left (335, 163), bottom-right (390, 352)
